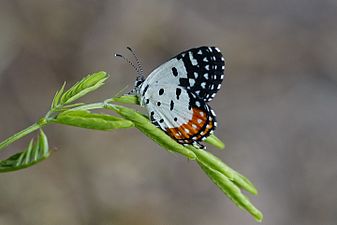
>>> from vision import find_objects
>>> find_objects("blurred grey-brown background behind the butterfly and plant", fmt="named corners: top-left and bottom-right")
top-left (0, 0), bottom-right (337, 225)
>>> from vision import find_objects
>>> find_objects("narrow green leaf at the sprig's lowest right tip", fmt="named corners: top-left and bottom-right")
top-left (198, 162), bottom-right (263, 222)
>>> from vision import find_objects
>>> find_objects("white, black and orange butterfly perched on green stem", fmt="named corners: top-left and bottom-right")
top-left (116, 46), bottom-right (225, 148)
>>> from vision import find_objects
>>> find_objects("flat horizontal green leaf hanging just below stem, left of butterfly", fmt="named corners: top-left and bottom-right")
top-left (53, 110), bottom-right (134, 130)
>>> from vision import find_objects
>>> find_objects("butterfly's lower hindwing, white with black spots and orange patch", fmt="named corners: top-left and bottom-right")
top-left (143, 85), bottom-right (216, 147)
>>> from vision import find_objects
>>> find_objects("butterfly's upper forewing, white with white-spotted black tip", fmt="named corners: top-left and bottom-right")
top-left (147, 47), bottom-right (225, 102)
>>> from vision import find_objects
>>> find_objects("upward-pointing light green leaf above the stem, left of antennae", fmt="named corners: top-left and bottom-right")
top-left (52, 71), bottom-right (108, 109)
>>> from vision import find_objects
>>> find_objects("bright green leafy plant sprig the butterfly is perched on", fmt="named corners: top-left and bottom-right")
top-left (0, 72), bottom-right (263, 221)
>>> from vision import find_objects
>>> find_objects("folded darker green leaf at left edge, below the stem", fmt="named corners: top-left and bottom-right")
top-left (0, 129), bottom-right (50, 173)
